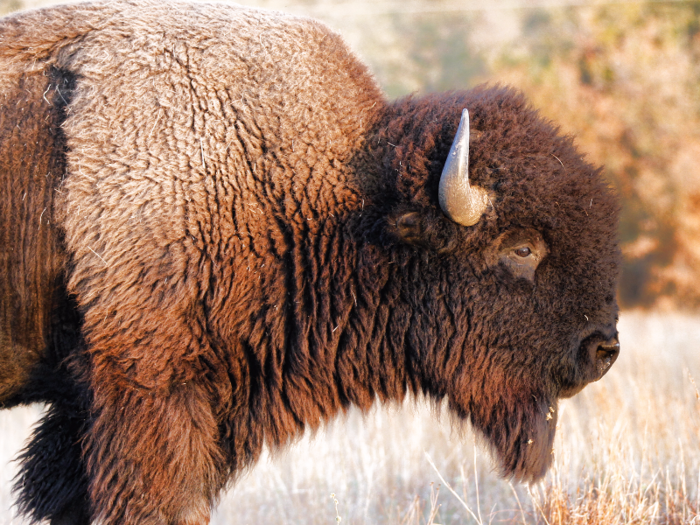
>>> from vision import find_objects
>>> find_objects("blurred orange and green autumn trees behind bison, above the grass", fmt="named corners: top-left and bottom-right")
top-left (5, 0), bottom-right (700, 309)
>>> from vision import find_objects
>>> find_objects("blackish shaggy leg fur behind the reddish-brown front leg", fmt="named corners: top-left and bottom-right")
top-left (15, 285), bottom-right (90, 525)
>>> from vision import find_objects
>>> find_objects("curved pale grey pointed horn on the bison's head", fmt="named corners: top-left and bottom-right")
top-left (438, 109), bottom-right (489, 226)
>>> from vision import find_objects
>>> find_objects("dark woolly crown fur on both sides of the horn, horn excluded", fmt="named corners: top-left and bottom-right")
top-left (371, 86), bottom-right (618, 242)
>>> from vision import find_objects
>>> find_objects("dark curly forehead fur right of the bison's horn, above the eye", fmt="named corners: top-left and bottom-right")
top-left (464, 88), bottom-right (619, 254)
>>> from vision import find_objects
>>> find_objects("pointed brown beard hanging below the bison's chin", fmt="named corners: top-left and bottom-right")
top-left (456, 394), bottom-right (557, 483)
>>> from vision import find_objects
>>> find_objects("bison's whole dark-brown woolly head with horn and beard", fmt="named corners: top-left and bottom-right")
top-left (364, 88), bottom-right (620, 481)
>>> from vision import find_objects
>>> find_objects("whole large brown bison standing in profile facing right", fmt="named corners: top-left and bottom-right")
top-left (0, 0), bottom-right (620, 525)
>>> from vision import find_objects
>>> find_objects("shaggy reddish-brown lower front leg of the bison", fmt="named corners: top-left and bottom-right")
top-left (87, 378), bottom-right (223, 525)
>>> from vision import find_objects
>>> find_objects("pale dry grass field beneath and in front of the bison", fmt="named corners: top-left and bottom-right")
top-left (0, 312), bottom-right (700, 525)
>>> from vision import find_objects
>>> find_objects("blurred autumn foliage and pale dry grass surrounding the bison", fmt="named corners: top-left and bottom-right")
top-left (0, 0), bottom-right (700, 525)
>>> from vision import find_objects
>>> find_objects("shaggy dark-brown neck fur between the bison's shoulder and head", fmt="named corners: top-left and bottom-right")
top-left (213, 101), bottom-right (466, 471)
